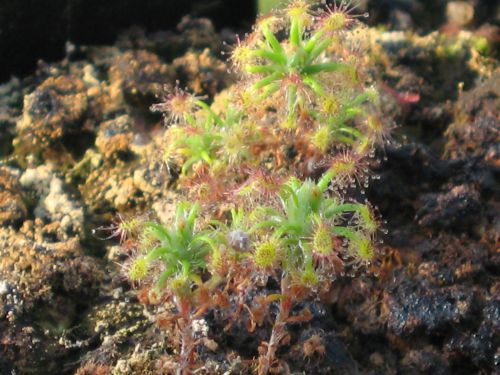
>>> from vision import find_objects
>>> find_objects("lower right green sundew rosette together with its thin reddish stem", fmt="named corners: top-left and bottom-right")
top-left (245, 172), bottom-right (377, 374)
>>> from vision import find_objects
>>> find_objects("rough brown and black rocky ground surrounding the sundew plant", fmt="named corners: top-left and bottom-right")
top-left (0, 1), bottom-right (500, 375)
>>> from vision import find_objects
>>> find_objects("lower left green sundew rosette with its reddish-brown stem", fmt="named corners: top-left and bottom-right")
top-left (123, 202), bottom-right (223, 373)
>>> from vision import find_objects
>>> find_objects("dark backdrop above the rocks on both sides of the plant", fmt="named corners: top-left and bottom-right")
top-left (0, 0), bottom-right (500, 82)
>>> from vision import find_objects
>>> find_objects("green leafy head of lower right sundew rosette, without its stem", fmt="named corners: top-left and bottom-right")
top-left (250, 174), bottom-right (379, 284)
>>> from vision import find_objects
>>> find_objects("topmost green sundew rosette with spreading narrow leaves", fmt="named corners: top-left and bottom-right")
top-left (233, 0), bottom-right (372, 126)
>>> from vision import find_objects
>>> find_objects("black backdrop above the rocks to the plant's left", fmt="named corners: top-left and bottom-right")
top-left (0, 0), bottom-right (256, 82)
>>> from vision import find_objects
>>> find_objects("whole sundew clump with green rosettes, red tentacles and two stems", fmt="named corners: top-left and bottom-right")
top-left (116, 0), bottom-right (388, 374)
